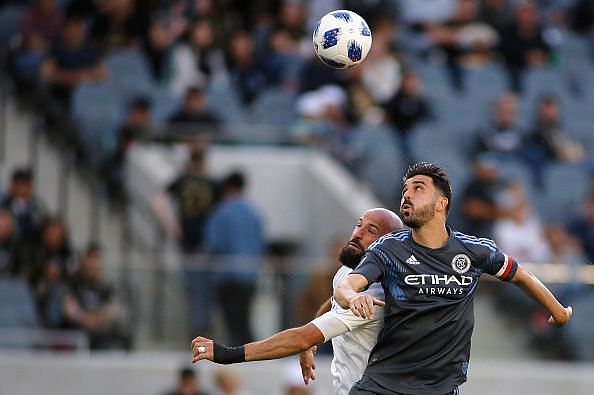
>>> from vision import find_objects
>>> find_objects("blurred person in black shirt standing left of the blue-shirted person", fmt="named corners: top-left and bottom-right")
top-left (153, 144), bottom-right (218, 254)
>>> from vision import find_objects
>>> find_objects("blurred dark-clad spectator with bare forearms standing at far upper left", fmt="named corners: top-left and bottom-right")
top-left (41, 16), bottom-right (107, 124)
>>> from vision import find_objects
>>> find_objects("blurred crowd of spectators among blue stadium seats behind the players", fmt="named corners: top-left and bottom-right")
top-left (0, 0), bottom-right (594, 358)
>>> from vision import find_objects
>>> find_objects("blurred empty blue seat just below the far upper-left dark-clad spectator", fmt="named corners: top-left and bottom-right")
top-left (72, 82), bottom-right (125, 159)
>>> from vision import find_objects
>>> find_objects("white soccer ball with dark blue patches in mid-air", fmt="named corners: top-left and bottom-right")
top-left (313, 10), bottom-right (371, 69)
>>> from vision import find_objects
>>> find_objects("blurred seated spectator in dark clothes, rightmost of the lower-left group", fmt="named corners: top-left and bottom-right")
top-left (64, 245), bottom-right (130, 350)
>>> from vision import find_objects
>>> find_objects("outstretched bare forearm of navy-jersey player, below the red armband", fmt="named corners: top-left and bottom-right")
top-left (511, 265), bottom-right (572, 326)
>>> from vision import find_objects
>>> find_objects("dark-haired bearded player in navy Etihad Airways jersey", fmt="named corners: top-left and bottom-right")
top-left (334, 163), bottom-right (572, 395)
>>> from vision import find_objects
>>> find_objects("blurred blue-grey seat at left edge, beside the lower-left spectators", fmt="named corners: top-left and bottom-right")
top-left (0, 278), bottom-right (39, 328)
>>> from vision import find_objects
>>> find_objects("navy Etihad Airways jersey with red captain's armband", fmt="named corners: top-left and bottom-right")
top-left (353, 228), bottom-right (517, 394)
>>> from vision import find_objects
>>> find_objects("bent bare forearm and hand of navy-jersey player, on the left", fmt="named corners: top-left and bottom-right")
top-left (334, 273), bottom-right (385, 318)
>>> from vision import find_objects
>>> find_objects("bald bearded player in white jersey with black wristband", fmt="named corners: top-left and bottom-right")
top-left (192, 208), bottom-right (403, 395)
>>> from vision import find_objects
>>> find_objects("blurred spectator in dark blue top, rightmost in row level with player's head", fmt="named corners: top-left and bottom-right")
top-left (522, 95), bottom-right (584, 188)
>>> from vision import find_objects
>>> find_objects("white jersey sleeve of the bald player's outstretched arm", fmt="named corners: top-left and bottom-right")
top-left (311, 306), bottom-right (383, 342)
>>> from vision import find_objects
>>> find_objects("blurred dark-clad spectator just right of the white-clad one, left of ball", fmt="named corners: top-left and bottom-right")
top-left (228, 31), bottom-right (269, 106)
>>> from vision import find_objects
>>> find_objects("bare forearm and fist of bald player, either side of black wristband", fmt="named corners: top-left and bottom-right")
top-left (192, 323), bottom-right (324, 362)
